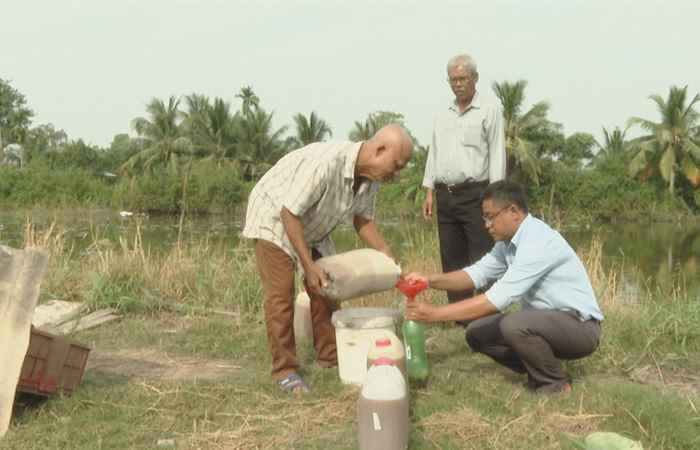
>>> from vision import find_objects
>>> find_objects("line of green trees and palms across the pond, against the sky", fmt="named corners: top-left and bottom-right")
top-left (0, 79), bottom-right (700, 215)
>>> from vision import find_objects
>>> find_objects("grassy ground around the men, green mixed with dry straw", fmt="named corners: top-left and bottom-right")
top-left (0, 223), bottom-right (700, 450)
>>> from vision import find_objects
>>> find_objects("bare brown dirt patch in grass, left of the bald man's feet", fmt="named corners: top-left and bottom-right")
top-left (87, 349), bottom-right (240, 380)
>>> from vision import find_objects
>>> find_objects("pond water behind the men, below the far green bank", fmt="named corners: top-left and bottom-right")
top-left (0, 209), bottom-right (700, 297)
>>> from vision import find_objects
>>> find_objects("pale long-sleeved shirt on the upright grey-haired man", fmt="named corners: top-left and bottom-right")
top-left (423, 92), bottom-right (506, 189)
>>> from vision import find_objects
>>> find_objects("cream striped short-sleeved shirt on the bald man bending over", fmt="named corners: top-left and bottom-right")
top-left (242, 142), bottom-right (380, 260)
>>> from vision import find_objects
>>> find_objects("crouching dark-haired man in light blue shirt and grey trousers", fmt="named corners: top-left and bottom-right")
top-left (406, 181), bottom-right (603, 393)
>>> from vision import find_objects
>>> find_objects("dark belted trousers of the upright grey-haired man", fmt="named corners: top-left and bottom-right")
top-left (435, 183), bottom-right (493, 303)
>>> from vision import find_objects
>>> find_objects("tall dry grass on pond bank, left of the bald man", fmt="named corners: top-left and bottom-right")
top-left (25, 220), bottom-right (260, 314)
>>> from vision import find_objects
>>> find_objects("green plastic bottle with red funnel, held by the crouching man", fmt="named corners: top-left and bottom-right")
top-left (396, 279), bottom-right (430, 383)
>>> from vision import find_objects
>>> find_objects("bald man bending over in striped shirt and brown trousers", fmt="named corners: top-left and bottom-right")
top-left (243, 124), bottom-right (413, 392)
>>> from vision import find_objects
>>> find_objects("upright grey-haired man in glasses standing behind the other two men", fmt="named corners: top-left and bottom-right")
top-left (423, 51), bottom-right (506, 303)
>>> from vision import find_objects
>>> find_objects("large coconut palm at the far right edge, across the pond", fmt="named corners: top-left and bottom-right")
top-left (627, 86), bottom-right (700, 195)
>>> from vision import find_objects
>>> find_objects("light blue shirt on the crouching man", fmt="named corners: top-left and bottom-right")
top-left (464, 214), bottom-right (603, 321)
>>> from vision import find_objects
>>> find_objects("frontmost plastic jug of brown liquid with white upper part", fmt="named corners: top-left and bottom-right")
top-left (357, 365), bottom-right (409, 450)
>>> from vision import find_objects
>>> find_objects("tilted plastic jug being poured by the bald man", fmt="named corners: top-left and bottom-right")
top-left (316, 248), bottom-right (401, 301)
